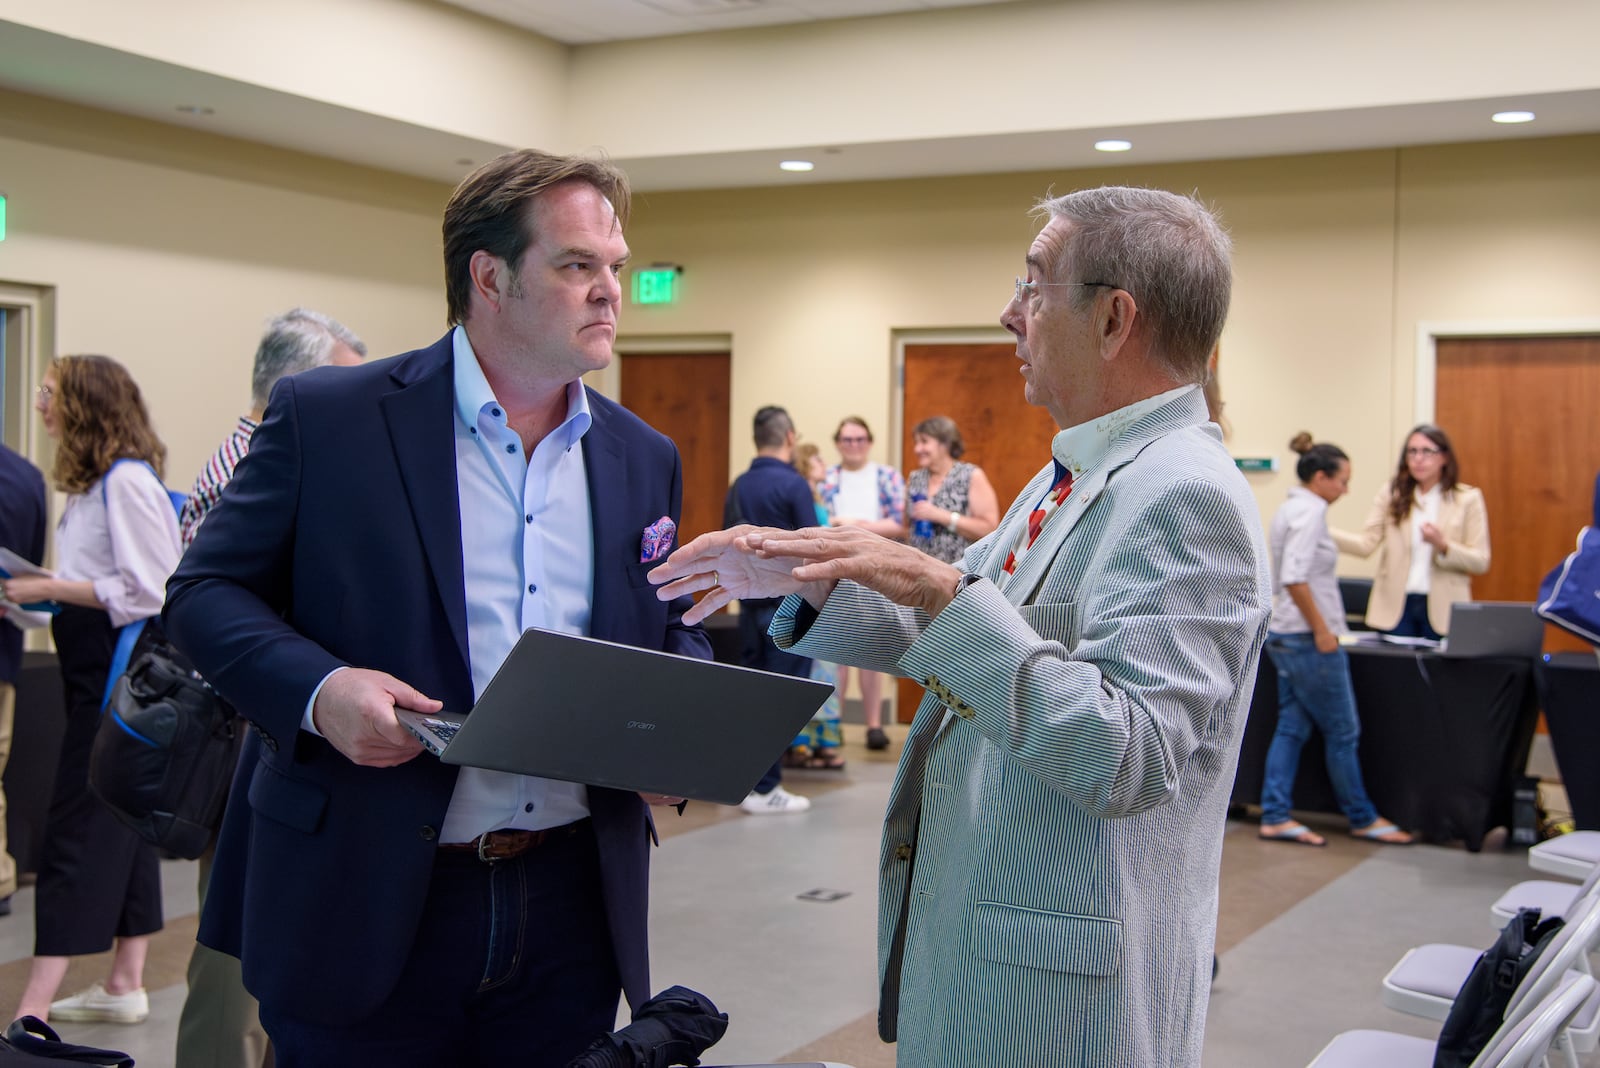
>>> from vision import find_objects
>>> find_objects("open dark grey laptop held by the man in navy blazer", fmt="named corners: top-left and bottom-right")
top-left (398, 628), bottom-right (832, 804)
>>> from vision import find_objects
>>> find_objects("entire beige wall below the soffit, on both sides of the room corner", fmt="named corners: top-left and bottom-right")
top-left (0, 94), bottom-right (1600, 562)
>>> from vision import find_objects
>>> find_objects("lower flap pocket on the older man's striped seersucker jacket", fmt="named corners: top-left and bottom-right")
top-left (973, 902), bottom-right (1122, 977)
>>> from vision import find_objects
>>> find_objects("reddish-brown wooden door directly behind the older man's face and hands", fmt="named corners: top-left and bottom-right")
top-left (896, 341), bottom-right (1059, 723)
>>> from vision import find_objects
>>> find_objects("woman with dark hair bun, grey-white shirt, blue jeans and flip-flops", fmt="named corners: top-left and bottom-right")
top-left (1261, 433), bottom-right (1411, 846)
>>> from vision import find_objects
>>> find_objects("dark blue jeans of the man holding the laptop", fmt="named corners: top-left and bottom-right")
top-left (261, 820), bottom-right (622, 1068)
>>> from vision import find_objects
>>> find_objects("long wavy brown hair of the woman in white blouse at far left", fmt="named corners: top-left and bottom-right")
top-left (50, 357), bottom-right (166, 492)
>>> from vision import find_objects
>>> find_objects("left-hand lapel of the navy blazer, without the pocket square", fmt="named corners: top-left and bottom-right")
top-left (379, 334), bottom-right (472, 670)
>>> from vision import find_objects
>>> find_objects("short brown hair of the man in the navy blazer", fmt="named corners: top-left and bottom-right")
top-left (445, 149), bottom-right (630, 326)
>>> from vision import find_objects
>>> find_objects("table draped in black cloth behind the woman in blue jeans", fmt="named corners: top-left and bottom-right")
top-left (1232, 644), bottom-right (1538, 852)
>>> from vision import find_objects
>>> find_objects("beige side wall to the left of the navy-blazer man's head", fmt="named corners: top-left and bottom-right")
top-left (0, 94), bottom-right (448, 488)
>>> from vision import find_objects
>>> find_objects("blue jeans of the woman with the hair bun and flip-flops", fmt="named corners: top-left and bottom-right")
top-left (1261, 633), bottom-right (1378, 827)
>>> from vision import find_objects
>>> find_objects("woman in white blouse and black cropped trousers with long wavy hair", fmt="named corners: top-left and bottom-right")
top-left (5, 357), bottom-right (181, 1023)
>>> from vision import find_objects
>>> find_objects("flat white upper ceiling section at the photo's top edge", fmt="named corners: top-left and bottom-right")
top-left (445, 0), bottom-right (1014, 45)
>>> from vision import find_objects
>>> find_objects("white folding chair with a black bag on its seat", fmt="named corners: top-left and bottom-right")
top-left (1382, 894), bottom-right (1600, 1052)
